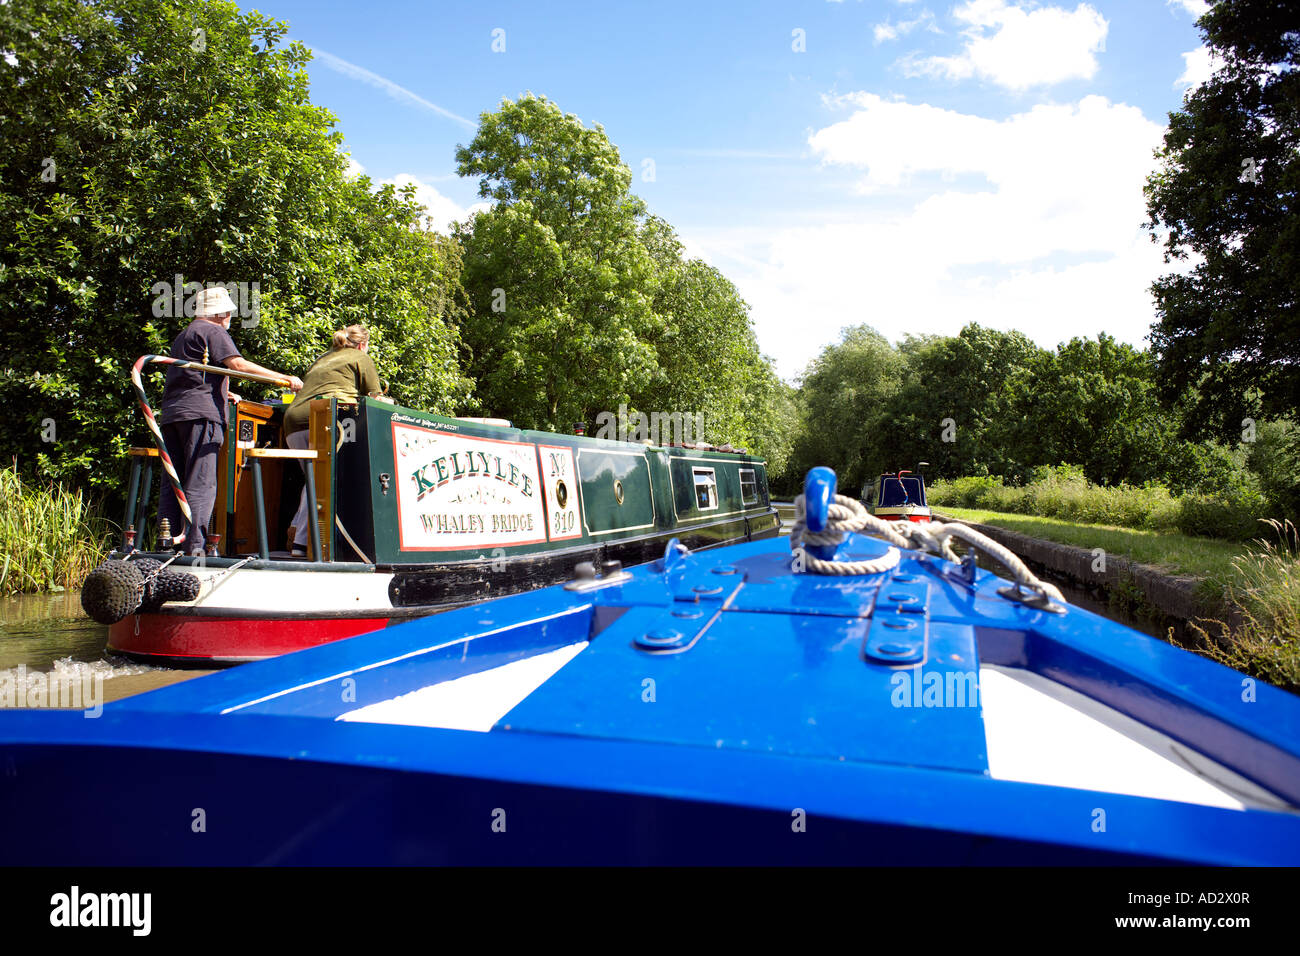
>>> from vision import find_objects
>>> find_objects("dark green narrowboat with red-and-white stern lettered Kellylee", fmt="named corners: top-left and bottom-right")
top-left (91, 356), bottom-right (780, 667)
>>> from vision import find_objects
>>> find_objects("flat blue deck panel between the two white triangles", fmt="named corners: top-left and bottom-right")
top-left (494, 608), bottom-right (988, 774)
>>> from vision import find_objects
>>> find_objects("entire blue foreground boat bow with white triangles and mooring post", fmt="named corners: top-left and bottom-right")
top-left (0, 470), bottom-right (1300, 865)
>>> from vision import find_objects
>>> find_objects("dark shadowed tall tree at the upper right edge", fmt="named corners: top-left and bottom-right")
top-left (1147, 0), bottom-right (1300, 441)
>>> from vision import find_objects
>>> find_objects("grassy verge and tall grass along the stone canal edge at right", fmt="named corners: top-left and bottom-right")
top-left (936, 507), bottom-right (1300, 693)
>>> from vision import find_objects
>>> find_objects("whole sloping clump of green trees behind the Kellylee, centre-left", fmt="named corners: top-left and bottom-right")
top-left (456, 95), bottom-right (790, 471)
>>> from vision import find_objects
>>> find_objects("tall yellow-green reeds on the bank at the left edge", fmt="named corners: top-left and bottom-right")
top-left (0, 467), bottom-right (113, 593)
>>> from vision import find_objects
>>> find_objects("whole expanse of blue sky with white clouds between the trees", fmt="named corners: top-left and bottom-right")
top-left (259, 0), bottom-right (1208, 377)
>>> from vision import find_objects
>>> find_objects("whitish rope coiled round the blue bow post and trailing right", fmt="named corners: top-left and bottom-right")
top-left (790, 494), bottom-right (1065, 601)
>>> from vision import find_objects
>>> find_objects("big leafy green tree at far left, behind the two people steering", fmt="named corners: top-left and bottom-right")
top-left (0, 0), bottom-right (468, 484)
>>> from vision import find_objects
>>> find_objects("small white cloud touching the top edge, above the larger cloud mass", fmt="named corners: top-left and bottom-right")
top-left (900, 0), bottom-right (1110, 90)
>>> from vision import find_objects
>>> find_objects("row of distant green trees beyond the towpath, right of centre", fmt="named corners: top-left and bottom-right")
top-left (783, 324), bottom-right (1279, 507)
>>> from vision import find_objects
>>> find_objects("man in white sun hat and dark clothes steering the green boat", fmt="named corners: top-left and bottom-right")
top-left (159, 286), bottom-right (303, 554)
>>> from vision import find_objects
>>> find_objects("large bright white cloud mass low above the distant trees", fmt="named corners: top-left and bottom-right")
top-left (684, 94), bottom-right (1169, 376)
